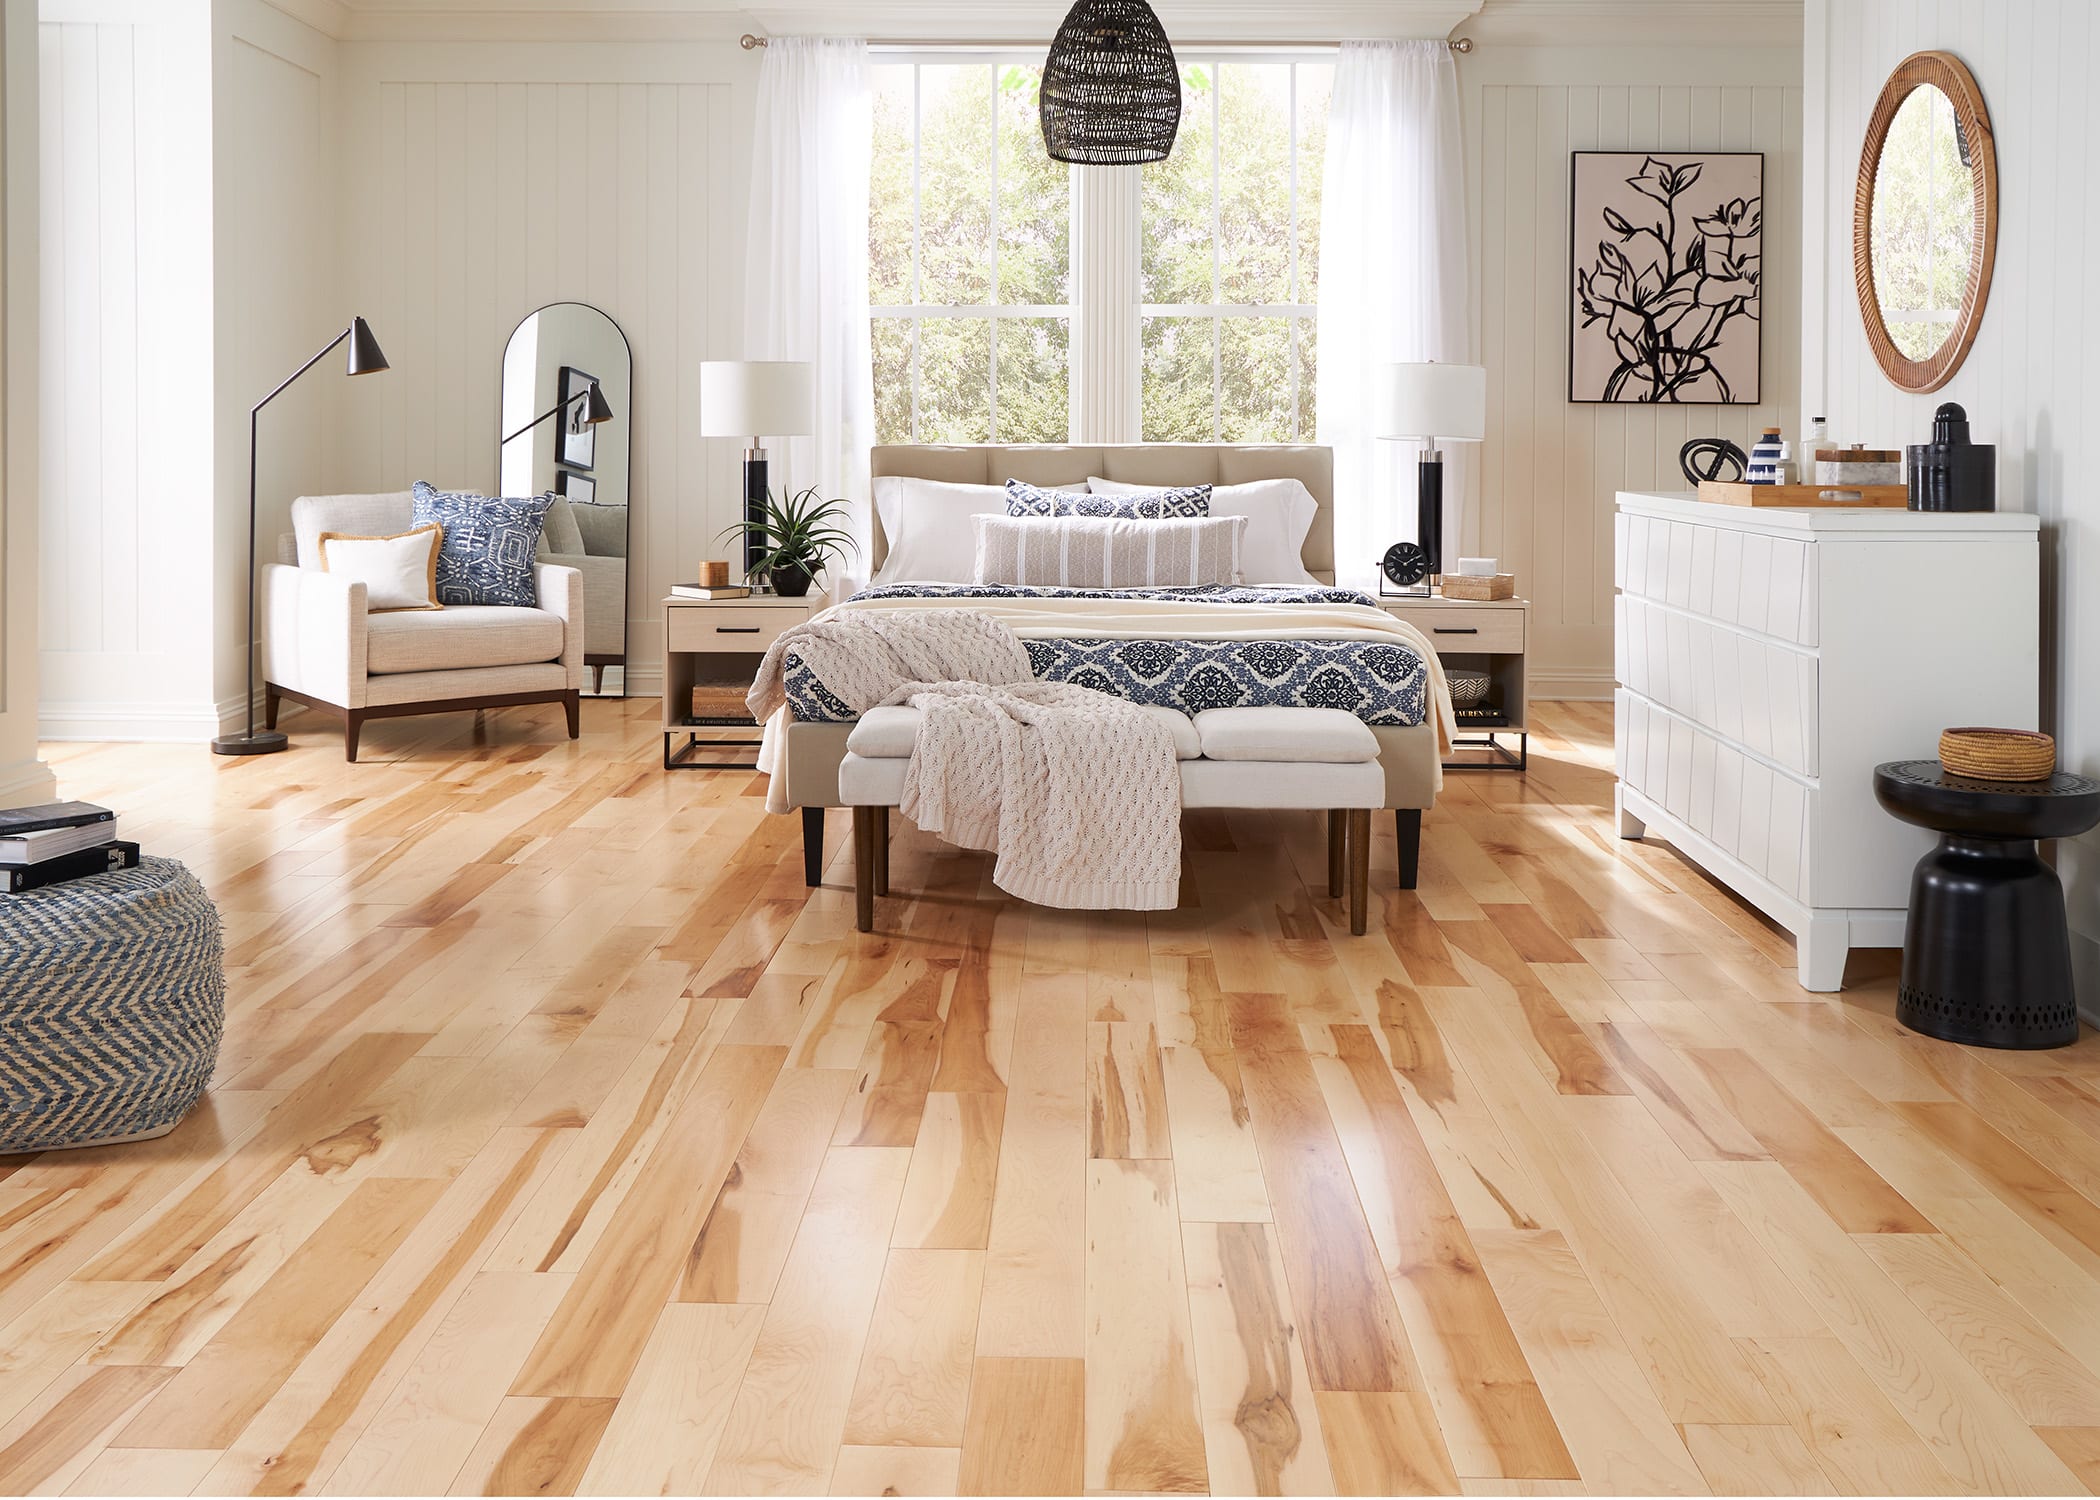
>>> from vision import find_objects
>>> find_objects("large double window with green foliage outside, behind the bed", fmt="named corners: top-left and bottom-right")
top-left (867, 48), bottom-right (1334, 443)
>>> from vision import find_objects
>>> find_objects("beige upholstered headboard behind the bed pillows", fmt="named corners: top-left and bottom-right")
top-left (869, 443), bottom-right (1334, 582)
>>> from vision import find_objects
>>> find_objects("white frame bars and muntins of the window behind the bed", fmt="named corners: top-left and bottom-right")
top-left (867, 40), bottom-right (1340, 443)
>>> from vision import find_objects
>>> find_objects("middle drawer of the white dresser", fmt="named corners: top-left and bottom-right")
top-left (1613, 595), bottom-right (1821, 777)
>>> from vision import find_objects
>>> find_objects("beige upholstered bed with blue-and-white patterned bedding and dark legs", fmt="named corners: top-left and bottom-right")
top-left (769, 443), bottom-right (1443, 889)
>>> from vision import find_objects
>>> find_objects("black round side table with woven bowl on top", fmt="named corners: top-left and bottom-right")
top-left (1873, 761), bottom-right (2100, 1048)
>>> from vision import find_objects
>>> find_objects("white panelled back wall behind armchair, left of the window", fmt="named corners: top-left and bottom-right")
top-left (334, 27), bottom-right (758, 693)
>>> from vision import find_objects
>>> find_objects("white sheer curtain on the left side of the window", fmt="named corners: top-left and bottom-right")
top-left (743, 36), bottom-right (876, 584)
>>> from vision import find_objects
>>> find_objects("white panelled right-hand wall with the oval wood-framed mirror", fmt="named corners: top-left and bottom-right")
top-left (1802, 0), bottom-right (2100, 1017)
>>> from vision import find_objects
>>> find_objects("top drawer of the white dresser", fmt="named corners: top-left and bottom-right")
top-left (1613, 513), bottom-right (1821, 647)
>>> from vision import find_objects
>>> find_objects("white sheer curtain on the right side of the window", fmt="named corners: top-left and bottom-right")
top-left (1319, 42), bottom-right (1470, 582)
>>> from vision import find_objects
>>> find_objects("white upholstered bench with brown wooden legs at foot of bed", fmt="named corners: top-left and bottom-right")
top-left (838, 708), bottom-right (1394, 935)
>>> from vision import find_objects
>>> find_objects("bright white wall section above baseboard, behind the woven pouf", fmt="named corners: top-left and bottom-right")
top-left (38, 0), bottom-right (218, 739)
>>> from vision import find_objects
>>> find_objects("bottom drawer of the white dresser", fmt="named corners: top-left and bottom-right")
top-left (1615, 687), bottom-right (1817, 901)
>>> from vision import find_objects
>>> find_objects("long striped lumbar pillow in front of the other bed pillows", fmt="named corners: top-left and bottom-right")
top-left (970, 515), bottom-right (1247, 588)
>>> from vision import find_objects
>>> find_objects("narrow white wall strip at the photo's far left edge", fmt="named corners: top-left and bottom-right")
top-left (0, 0), bottom-right (50, 807)
